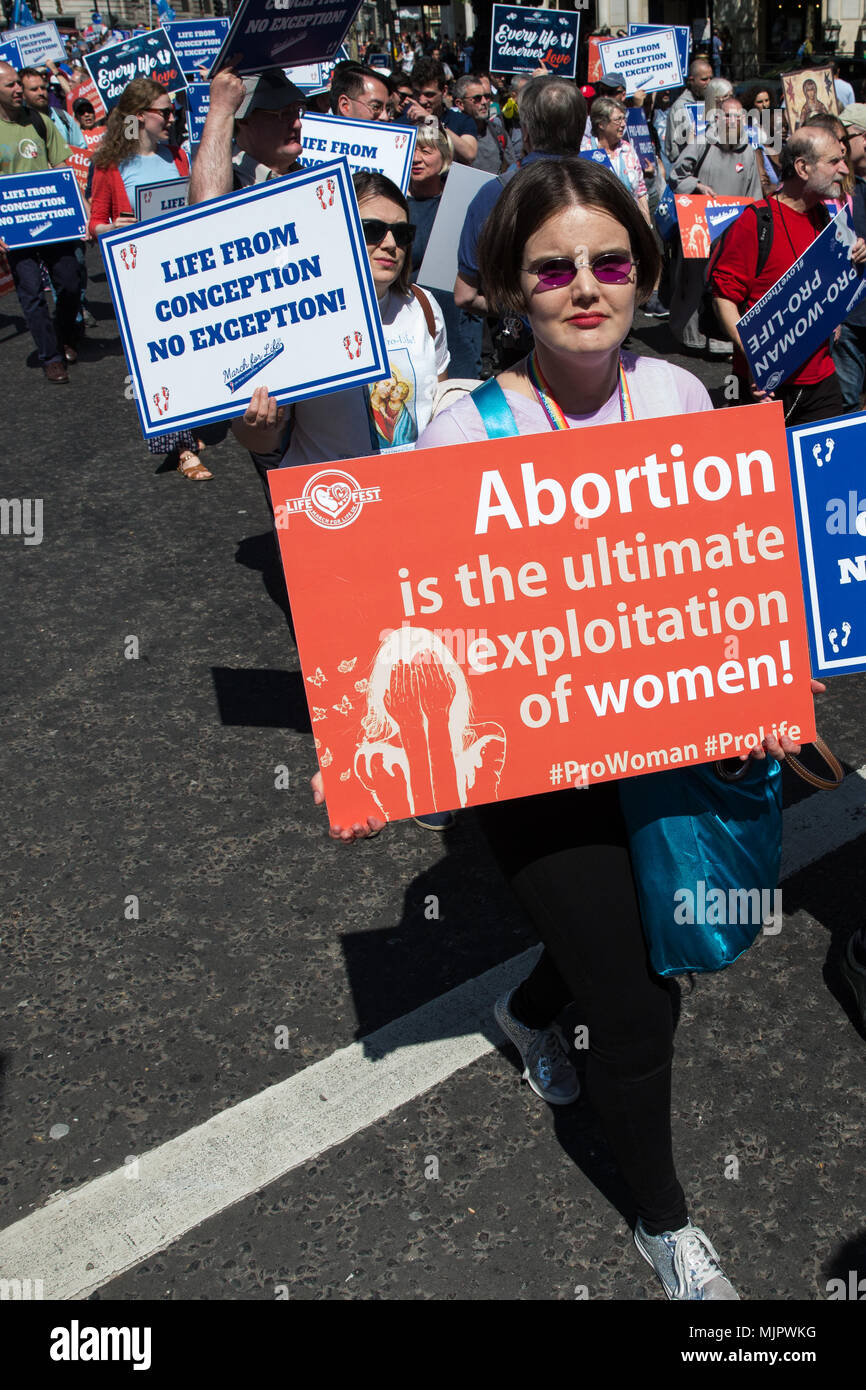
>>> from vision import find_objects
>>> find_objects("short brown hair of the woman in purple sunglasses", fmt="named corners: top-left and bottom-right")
top-left (478, 158), bottom-right (660, 314)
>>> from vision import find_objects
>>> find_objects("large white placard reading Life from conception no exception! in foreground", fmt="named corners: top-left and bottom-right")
top-left (100, 160), bottom-right (388, 438)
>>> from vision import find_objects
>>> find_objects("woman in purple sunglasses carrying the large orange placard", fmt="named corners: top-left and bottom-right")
top-left (323, 158), bottom-right (796, 1300)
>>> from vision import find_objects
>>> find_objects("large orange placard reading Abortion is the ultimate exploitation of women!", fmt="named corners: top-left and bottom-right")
top-left (268, 404), bottom-right (815, 826)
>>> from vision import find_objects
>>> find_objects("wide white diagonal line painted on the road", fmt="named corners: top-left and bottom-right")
top-left (0, 765), bottom-right (866, 1300)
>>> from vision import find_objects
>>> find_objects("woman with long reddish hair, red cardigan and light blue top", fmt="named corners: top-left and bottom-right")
top-left (90, 78), bottom-right (213, 482)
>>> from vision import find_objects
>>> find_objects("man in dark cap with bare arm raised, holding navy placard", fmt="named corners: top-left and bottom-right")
top-left (189, 68), bottom-right (304, 203)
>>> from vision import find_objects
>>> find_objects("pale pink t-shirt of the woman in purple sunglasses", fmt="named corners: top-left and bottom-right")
top-left (416, 352), bottom-right (713, 449)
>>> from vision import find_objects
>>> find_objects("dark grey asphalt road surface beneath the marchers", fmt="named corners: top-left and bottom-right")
top-left (0, 250), bottom-right (866, 1317)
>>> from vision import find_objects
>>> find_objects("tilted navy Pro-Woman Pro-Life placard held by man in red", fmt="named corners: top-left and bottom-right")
top-left (737, 207), bottom-right (866, 391)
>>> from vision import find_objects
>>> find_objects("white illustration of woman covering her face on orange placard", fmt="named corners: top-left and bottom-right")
top-left (354, 627), bottom-right (506, 820)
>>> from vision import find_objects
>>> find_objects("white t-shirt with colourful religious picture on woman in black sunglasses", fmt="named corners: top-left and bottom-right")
top-left (281, 289), bottom-right (450, 468)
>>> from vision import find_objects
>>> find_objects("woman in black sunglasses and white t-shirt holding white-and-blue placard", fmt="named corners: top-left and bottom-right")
top-left (232, 166), bottom-right (449, 467)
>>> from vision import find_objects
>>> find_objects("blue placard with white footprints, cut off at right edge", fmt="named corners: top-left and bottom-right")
top-left (788, 416), bottom-right (866, 676)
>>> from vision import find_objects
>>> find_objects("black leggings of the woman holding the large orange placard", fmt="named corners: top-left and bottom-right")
top-left (480, 783), bottom-right (688, 1234)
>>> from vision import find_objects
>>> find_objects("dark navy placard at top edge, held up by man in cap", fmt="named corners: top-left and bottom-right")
top-left (210, 0), bottom-right (360, 76)
